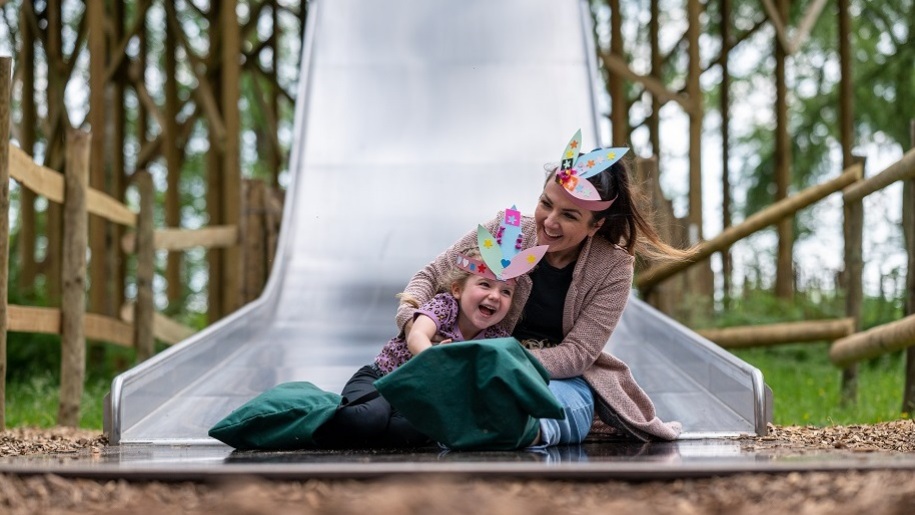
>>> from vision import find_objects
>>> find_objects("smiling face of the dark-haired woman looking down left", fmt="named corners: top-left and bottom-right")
top-left (534, 177), bottom-right (604, 267)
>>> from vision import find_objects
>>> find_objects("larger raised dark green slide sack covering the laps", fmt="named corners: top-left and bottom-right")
top-left (375, 338), bottom-right (564, 450)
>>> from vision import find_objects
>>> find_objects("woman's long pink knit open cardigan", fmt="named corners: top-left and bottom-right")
top-left (396, 213), bottom-right (681, 441)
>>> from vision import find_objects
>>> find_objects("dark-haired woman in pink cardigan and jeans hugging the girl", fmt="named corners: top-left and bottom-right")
top-left (397, 131), bottom-right (689, 445)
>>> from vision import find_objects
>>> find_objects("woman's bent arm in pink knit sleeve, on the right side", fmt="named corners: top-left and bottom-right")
top-left (531, 255), bottom-right (632, 379)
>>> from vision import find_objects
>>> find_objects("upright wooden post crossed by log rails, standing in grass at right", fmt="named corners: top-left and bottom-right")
top-left (841, 158), bottom-right (864, 404)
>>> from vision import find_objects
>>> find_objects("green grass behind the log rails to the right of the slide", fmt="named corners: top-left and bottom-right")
top-left (734, 343), bottom-right (909, 426)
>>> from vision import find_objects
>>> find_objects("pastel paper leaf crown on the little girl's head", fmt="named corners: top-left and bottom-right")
top-left (455, 206), bottom-right (550, 281)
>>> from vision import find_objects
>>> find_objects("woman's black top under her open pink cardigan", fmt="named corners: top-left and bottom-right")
top-left (512, 259), bottom-right (575, 347)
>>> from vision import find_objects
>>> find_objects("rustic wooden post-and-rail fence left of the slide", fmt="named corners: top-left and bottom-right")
top-left (0, 57), bottom-right (281, 429)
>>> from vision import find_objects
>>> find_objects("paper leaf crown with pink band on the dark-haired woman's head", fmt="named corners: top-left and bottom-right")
top-left (556, 129), bottom-right (629, 211)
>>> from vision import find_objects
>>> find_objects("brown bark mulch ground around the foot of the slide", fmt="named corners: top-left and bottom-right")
top-left (0, 420), bottom-right (915, 515)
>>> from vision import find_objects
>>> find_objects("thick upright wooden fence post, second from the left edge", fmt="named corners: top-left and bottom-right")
top-left (57, 129), bottom-right (92, 427)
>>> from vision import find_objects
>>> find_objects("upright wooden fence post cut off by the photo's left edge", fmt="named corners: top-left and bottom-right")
top-left (0, 57), bottom-right (13, 431)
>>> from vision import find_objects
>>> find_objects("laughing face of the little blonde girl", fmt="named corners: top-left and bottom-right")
top-left (451, 275), bottom-right (515, 340)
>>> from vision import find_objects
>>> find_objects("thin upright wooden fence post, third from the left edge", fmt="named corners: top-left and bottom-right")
top-left (133, 170), bottom-right (156, 362)
